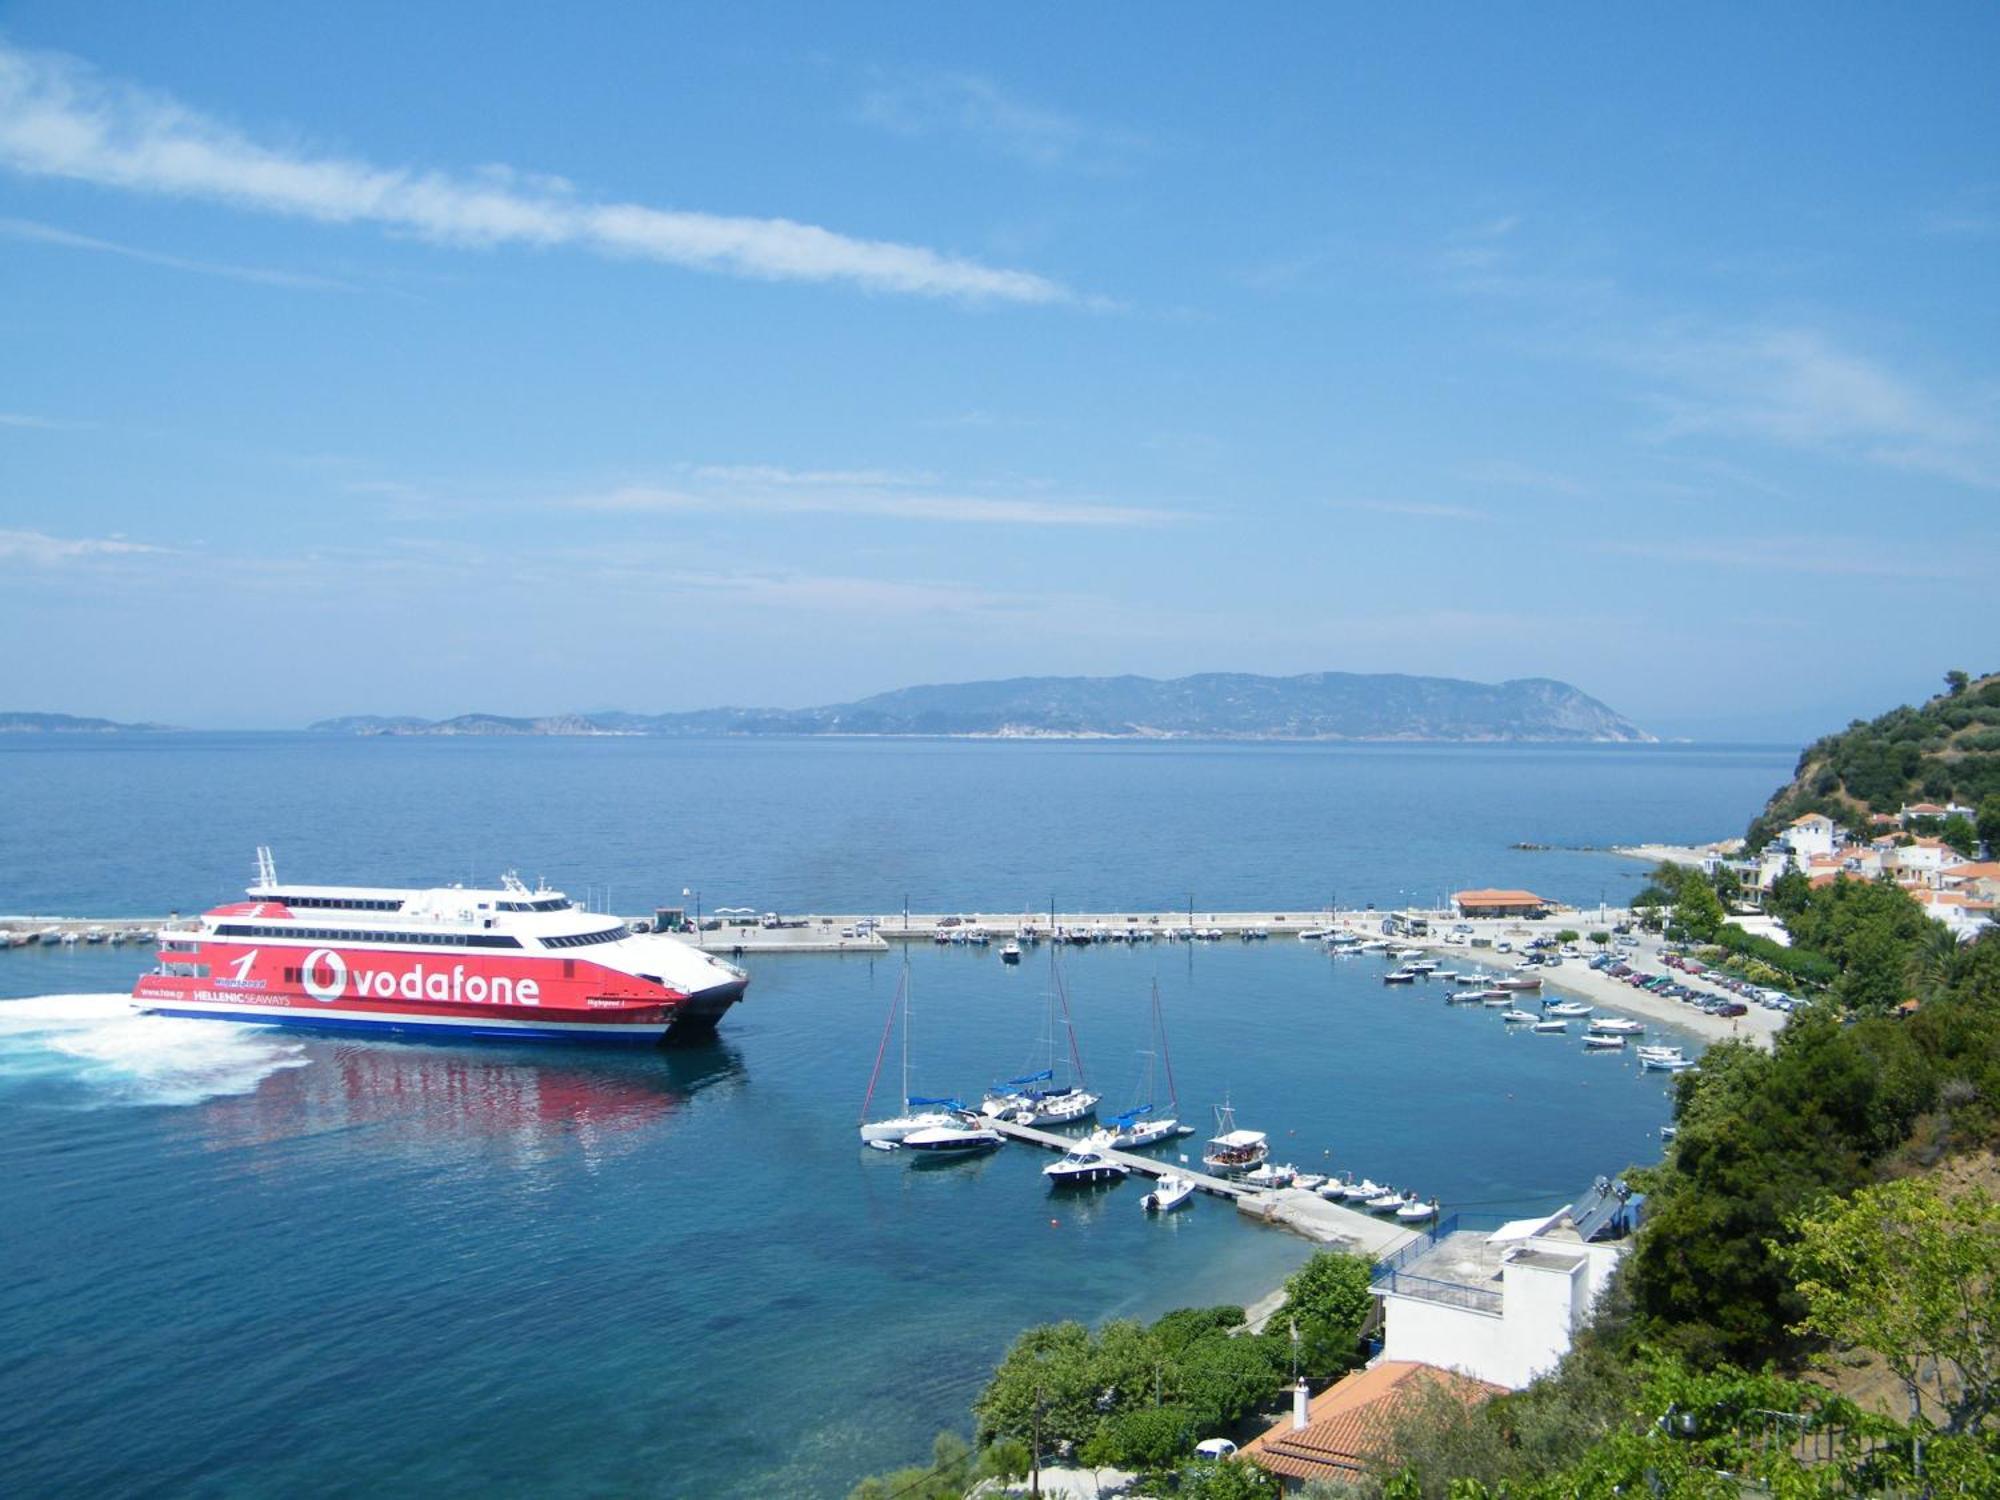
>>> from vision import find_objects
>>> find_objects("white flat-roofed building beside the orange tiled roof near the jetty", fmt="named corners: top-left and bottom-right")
top-left (1370, 1210), bottom-right (1626, 1390)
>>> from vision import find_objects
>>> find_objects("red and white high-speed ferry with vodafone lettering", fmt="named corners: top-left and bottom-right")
top-left (132, 848), bottom-right (748, 1044)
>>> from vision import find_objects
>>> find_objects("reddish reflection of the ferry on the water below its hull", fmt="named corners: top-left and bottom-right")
top-left (198, 1040), bottom-right (746, 1166)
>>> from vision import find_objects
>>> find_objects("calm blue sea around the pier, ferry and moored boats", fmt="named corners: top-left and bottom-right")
top-left (0, 734), bottom-right (1796, 1496)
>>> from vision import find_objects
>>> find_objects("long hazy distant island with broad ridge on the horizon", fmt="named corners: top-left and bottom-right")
top-left (310, 672), bottom-right (1654, 744)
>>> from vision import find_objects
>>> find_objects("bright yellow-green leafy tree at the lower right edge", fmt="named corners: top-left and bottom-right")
top-left (1778, 1178), bottom-right (2000, 1434)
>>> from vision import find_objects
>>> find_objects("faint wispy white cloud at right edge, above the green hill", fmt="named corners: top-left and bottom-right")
top-left (1612, 328), bottom-right (2000, 488)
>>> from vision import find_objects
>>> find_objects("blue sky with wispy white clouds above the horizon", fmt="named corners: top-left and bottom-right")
top-left (0, 0), bottom-right (2000, 740)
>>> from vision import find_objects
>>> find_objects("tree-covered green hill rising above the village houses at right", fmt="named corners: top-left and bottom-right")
top-left (1748, 672), bottom-right (2000, 848)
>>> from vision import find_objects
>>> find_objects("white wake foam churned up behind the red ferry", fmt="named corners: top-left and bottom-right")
top-left (0, 994), bottom-right (310, 1104)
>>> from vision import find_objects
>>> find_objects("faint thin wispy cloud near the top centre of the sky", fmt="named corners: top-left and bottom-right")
top-left (860, 70), bottom-right (1144, 172)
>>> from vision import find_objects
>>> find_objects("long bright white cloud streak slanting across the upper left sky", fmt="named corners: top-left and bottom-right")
top-left (0, 42), bottom-right (1072, 302)
